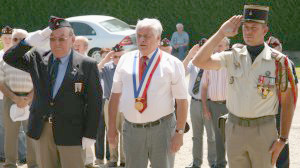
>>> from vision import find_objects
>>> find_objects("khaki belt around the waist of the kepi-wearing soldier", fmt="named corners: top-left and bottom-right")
top-left (228, 113), bottom-right (275, 127)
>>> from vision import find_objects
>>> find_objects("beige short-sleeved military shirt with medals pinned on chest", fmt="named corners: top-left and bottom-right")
top-left (213, 44), bottom-right (291, 118)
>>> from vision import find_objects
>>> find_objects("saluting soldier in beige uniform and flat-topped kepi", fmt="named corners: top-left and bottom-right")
top-left (193, 5), bottom-right (297, 168)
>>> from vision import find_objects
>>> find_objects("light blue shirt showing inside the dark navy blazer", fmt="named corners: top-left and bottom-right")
top-left (53, 51), bottom-right (71, 97)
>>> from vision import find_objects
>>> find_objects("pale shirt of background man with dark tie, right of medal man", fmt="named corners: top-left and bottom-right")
top-left (186, 61), bottom-right (203, 99)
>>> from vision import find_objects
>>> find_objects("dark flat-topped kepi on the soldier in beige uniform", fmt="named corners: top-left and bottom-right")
top-left (243, 5), bottom-right (269, 24)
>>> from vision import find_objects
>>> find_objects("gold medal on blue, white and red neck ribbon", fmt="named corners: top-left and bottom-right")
top-left (132, 48), bottom-right (162, 113)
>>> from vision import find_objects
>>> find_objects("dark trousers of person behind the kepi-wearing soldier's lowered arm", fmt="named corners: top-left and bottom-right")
top-left (276, 107), bottom-right (290, 168)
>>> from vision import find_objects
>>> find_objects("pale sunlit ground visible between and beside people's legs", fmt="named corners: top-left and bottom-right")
top-left (0, 85), bottom-right (300, 168)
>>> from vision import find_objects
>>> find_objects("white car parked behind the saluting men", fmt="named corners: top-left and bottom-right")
top-left (66, 15), bottom-right (137, 61)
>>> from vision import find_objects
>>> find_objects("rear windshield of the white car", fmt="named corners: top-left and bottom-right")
top-left (100, 19), bottom-right (130, 32)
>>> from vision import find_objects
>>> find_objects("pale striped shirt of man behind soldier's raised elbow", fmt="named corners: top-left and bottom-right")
top-left (201, 68), bottom-right (227, 101)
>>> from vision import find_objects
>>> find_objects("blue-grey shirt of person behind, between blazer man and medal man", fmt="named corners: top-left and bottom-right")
top-left (100, 61), bottom-right (117, 99)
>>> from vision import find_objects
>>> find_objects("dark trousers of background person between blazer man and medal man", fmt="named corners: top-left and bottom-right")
top-left (95, 99), bottom-right (110, 160)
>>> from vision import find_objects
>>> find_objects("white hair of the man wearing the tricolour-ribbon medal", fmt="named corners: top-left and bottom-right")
top-left (135, 18), bottom-right (163, 36)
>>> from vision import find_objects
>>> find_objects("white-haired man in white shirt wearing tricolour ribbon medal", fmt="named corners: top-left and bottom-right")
top-left (108, 18), bottom-right (188, 168)
